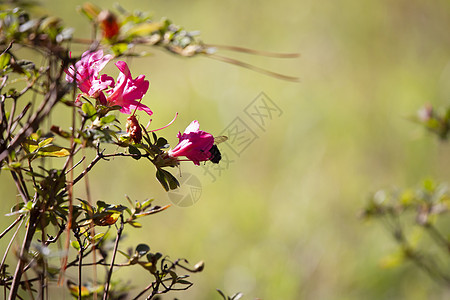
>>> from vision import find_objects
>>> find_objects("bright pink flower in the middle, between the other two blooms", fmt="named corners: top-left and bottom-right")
top-left (105, 61), bottom-right (153, 116)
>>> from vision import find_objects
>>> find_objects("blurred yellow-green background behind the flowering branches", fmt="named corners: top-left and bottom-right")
top-left (0, 0), bottom-right (450, 299)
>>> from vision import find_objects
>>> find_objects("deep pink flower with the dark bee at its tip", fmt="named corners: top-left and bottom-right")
top-left (168, 120), bottom-right (214, 166)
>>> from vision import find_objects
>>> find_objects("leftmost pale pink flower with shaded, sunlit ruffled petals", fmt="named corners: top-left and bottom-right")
top-left (66, 49), bottom-right (114, 98)
